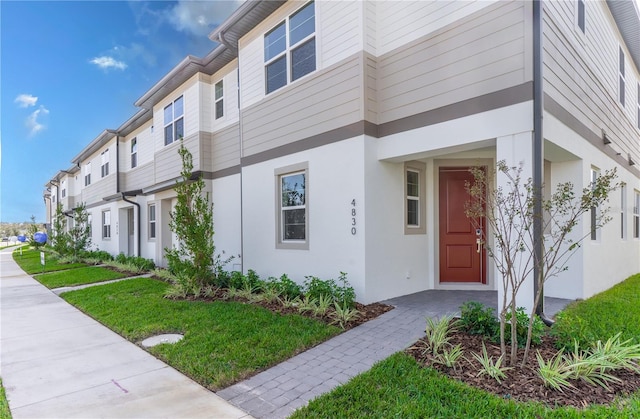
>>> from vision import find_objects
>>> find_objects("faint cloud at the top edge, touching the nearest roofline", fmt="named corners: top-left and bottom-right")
top-left (167, 0), bottom-right (242, 36)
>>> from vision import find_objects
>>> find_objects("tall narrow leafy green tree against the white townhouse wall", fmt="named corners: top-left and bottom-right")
top-left (165, 140), bottom-right (215, 291)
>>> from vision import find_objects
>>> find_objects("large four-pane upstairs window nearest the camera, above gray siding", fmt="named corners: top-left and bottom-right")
top-left (264, 2), bottom-right (316, 94)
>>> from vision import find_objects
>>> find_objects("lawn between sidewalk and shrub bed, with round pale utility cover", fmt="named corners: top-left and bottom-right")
top-left (62, 278), bottom-right (339, 390)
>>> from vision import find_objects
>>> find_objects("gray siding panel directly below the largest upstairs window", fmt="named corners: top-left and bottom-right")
top-left (242, 54), bottom-right (363, 156)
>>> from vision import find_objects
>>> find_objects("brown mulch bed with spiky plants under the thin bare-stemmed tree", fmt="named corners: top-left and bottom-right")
top-left (406, 331), bottom-right (640, 408)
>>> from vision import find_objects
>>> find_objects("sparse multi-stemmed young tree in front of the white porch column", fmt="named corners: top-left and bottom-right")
top-left (465, 161), bottom-right (618, 365)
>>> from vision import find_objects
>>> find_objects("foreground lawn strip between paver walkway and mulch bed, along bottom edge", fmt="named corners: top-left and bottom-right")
top-left (291, 353), bottom-right (640, 419)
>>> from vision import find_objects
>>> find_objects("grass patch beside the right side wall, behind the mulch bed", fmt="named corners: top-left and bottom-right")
top-left (552, 274), bottom-right (640, 349)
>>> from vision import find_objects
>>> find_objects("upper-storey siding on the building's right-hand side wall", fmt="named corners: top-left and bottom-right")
top-left (543, 2), bottom-right (640, 167)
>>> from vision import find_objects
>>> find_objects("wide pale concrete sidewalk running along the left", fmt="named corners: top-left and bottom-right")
top-left (0, 249), bottom-right (250, 419)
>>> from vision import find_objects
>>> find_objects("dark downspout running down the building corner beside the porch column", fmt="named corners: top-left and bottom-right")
top-left (533, 0), bottom-right (554, 326)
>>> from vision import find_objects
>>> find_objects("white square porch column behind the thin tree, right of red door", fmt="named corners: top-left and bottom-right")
top-left (494, 131), bottom-right (535, 313)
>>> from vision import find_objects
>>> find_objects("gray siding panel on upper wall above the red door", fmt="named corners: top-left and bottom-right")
top-left (376, 1), bottom-right (531, 123)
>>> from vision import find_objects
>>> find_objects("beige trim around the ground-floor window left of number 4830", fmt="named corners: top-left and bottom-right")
top-left (274, 162), bottom-right (309, 250)
